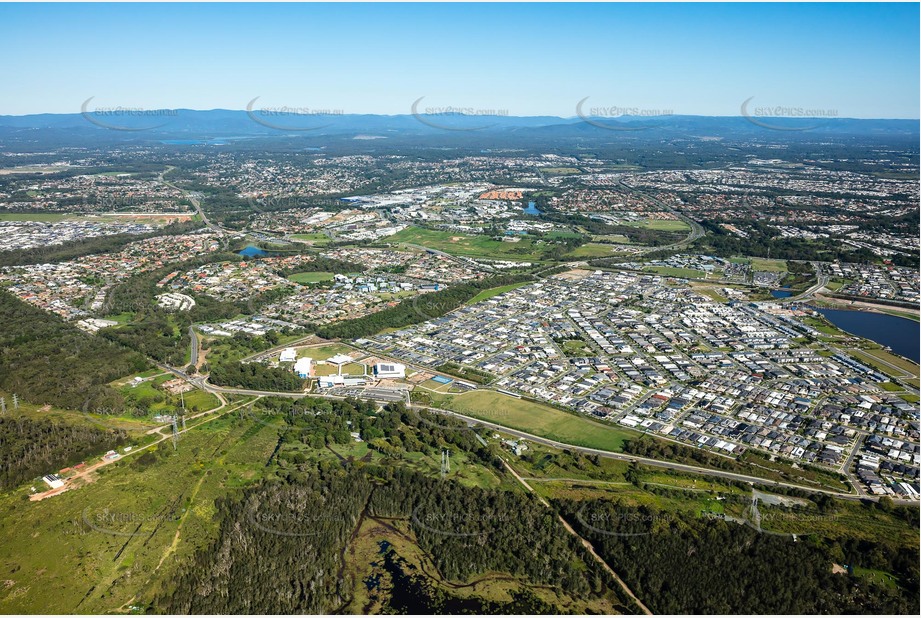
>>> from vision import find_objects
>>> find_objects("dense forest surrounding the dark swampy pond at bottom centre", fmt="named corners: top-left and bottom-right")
top-left (155, 398), bottom-right (631, 613)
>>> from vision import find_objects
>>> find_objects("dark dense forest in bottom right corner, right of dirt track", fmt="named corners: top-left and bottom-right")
top-left (554, 500), bottom-right (918, 615)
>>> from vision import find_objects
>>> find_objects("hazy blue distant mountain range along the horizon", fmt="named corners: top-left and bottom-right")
top-left (0, 108), bottom-right (921, 140)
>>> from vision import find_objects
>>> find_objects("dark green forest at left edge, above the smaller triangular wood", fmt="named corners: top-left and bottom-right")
top-left (0, 290), bottom-right (148, 410)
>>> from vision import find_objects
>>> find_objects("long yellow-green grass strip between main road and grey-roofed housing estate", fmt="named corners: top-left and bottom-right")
top-left (435, 390), bottom-right (639, 451)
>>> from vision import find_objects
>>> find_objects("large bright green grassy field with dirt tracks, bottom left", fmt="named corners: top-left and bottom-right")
top-left (0, 416), bottom-right (278, 614)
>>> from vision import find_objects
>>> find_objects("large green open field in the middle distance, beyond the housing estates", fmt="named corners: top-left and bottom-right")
top-left (386, 226), bottom-right (548, 261)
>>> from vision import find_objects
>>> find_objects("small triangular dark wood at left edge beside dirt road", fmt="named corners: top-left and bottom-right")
top-left (0, 415), bottom-right (128, 489)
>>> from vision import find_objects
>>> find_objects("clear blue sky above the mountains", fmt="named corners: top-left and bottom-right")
top-left (0, 3), bottom-right (919, 118)
